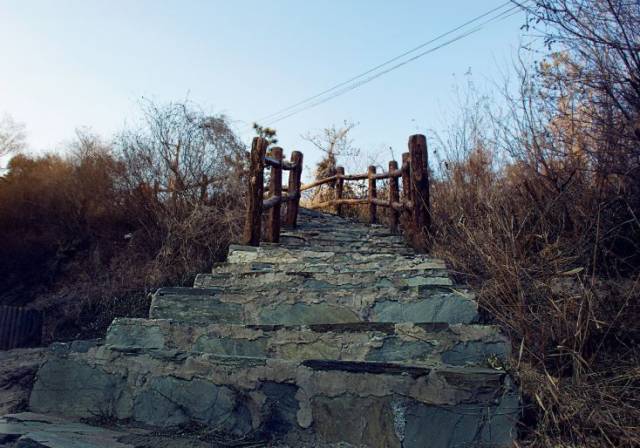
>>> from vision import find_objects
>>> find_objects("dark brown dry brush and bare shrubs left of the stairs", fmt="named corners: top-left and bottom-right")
top-left (0, 103), bottom-right (244, 340)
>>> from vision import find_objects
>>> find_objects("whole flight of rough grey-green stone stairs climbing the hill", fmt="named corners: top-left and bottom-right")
top-left (21, 210), bottom-right (519, 448)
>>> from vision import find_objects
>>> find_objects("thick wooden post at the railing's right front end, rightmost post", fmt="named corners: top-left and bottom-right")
top-left (409, 134), bottom-right (431, 243)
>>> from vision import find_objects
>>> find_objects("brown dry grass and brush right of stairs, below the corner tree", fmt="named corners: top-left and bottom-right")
top-left (432, 144), bottom-right (640, 447)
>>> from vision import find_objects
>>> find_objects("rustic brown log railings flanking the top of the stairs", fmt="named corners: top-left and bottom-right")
top-left (243, 134), bottom-right (431, 246)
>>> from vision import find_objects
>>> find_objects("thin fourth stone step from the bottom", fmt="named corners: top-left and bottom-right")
top-left (193, 269), bottom-right (453, 289)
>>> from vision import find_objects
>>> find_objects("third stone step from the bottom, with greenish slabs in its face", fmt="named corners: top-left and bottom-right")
top-left (149, 287), bottom-right (478, 325)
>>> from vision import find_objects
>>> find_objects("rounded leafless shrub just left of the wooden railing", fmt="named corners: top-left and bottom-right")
top-left (115, 101), bottom-right (246, 281)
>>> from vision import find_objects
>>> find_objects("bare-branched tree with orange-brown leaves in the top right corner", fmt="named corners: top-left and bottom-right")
top-left (528, 0), bottom-right (640, 172)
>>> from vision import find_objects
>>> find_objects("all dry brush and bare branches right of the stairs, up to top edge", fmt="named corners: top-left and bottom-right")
top-left (304, 0), bottom-right (640, 447)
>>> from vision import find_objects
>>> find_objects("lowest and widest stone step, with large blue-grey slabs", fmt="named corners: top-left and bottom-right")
top-left (30, 344), bottom-right (519, 448)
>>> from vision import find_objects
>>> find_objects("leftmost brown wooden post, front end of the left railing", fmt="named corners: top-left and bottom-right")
top-left (243, 137), bottom-right (269, 246)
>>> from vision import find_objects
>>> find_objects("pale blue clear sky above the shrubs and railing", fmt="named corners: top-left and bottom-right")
top-left (0, 0), bottom-right (524, 177)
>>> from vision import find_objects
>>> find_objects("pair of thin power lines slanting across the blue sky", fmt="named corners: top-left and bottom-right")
top-left (267, 0), bottom-right (529, 125)
